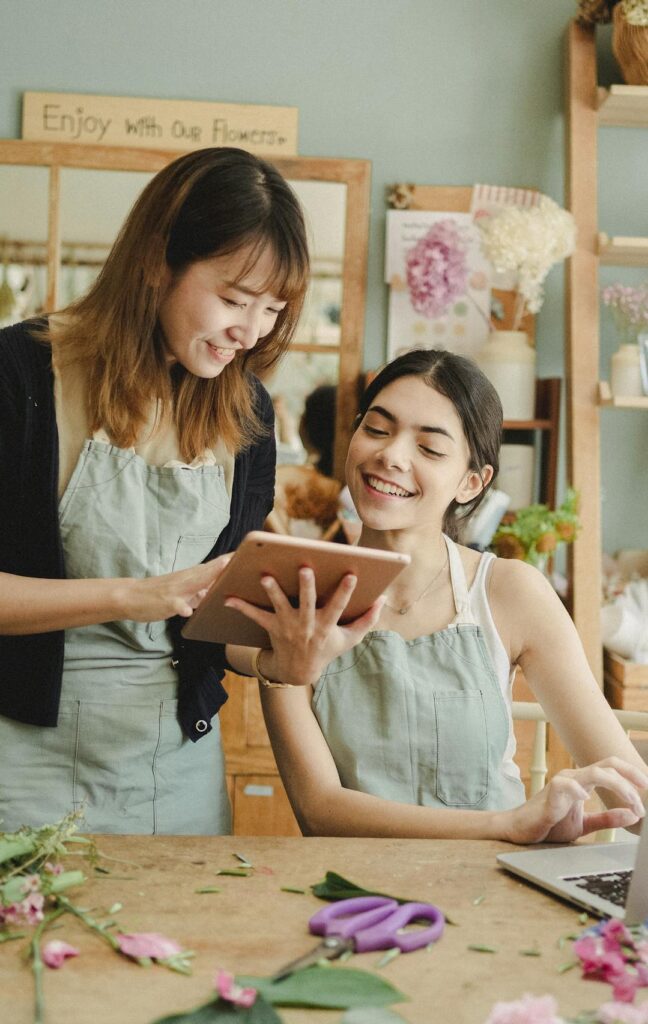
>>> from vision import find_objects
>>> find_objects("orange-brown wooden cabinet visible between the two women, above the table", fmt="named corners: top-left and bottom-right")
top-left (220, 673), bottom-right (301, 836)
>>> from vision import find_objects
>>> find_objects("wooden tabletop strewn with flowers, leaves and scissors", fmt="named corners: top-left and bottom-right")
top-left (0, 836), bottom-right (611, 1024)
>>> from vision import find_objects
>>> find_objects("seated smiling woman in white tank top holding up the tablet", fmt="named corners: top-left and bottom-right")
top-left (226, 351), bottom-right (648, 843)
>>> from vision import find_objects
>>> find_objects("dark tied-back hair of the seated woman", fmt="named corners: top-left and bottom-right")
top-left (357, 348), bottom-right (503, 540)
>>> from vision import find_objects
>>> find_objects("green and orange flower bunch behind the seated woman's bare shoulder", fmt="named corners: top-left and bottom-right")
top-left (490, 487), bottom-right (580, 566)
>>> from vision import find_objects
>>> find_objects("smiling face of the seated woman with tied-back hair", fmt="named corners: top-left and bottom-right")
top-left (346, 377), bottom-right (492, 531)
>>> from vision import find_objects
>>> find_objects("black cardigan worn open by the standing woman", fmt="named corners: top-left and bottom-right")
top-left (0, 322), bottom-right (275, 740)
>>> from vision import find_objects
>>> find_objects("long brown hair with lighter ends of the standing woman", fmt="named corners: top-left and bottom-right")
top-left (47, 146), bottom-right (309, 460)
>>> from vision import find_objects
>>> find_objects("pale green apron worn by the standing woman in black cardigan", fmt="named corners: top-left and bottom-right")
top-left (0, 439), bottom-right (230, 835)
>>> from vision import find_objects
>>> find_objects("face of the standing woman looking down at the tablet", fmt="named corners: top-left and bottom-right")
top-left (159, 241), bottom-right (286, 378)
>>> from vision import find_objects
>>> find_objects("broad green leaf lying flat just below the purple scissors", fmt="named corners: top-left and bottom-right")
top-left (236, 966), bottom-right (401, 1010)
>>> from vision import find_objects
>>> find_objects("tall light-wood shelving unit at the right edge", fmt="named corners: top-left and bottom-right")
top-left (565, 22), bottom-right (648, 685)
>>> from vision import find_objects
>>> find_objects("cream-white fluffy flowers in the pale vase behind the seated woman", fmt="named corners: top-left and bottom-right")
top-left (477, 196), bottom-right (576, 330)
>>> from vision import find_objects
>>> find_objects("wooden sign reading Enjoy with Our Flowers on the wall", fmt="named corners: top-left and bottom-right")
top-left (23, 92), bottom-right (299, 157)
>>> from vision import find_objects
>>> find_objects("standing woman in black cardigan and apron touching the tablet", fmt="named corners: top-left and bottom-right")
top-left (0, 147), bottom-right (309, 833)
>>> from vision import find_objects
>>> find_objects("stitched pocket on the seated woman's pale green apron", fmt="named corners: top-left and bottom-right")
top-left (434, 690), bottom-right (488, 807)
